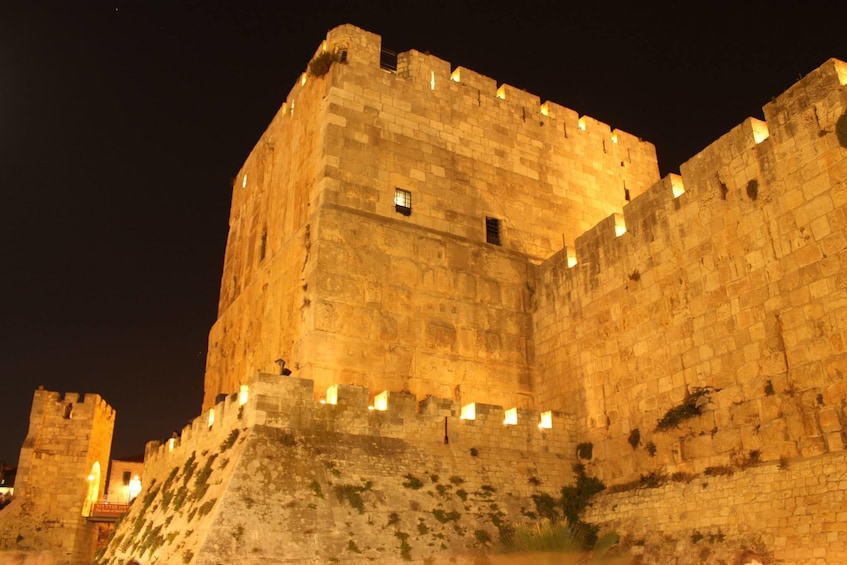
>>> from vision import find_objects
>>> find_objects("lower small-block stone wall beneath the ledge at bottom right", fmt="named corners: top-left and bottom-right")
top-left (586, 451), bottom-right (847, 565)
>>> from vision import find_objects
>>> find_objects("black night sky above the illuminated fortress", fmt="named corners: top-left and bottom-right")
top-left (0, 0), bottom-right (847, 464)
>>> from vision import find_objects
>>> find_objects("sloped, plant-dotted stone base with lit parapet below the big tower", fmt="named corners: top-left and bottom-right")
top-left (100, 375), bottom-right (575, 564)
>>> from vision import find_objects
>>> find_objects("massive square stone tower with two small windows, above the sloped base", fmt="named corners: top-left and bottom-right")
top-left (204, 25), bottom-right (659, 409)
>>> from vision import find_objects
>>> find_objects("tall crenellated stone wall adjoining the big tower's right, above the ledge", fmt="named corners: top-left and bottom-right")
top-left (534, 60), bottom-right (847, 483)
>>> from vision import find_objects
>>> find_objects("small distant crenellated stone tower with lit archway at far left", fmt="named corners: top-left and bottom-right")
top-left (0, 389), bottom-right (115, 564)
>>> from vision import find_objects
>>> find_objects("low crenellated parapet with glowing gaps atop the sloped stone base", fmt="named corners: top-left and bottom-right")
top-left (152, 373), bottom-right (575, 465)
